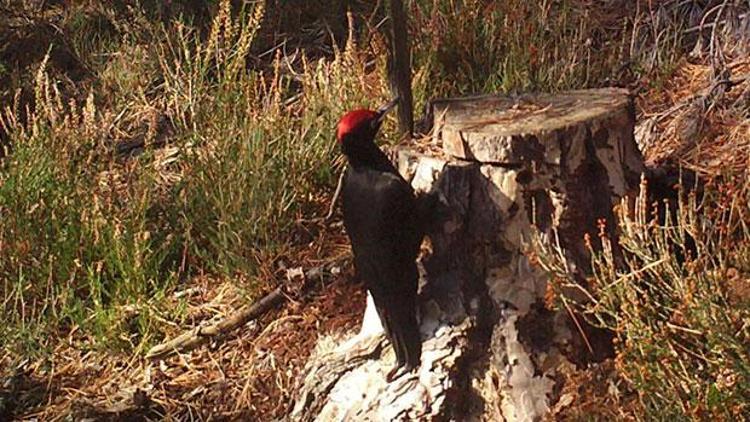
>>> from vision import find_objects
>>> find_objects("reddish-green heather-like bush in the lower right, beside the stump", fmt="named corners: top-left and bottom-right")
top-left (537, 177), bottom-right (750, 420)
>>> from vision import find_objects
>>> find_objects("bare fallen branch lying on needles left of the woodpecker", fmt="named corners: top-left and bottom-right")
top-left (146, 260), bottom-right (341, 359)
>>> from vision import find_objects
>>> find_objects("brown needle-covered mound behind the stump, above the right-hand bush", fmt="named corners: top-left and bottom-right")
top-left (639, 56), bottom-right (750, 176)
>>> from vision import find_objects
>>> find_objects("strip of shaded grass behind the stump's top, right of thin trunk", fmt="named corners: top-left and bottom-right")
top-left (410, 0), bottom-right (686, 99)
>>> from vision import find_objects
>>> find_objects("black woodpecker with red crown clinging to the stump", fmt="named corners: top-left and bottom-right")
top-left (336, 98), bottom-right (424, 382)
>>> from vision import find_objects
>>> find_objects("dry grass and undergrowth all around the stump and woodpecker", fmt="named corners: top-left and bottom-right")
top-left (0, 0), bottom-right (750, 420)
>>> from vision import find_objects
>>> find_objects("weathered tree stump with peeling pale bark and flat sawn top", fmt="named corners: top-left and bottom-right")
top-left (290, 89), bottom-right (644, 420)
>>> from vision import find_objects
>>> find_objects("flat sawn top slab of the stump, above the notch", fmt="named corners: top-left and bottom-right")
top-left (432, 88), bottom-right (632, 164)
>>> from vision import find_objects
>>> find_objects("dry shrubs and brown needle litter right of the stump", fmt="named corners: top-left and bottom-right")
top-left (537, 41), bottom-right (750, 420)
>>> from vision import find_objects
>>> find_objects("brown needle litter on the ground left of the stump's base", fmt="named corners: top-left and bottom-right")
top-left (0, 219), bottom-right (365, 420)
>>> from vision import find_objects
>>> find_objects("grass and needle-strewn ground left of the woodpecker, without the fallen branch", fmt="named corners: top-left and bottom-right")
top-left (0, 2), bottom-right (384, 419)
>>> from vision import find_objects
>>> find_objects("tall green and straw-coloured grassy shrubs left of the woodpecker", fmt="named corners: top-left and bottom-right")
top-left (0, 1), bottom-right (394, 353)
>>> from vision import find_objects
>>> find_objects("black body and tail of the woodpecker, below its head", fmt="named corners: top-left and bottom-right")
top-left (344, 173), bottom-right (421, 366)
